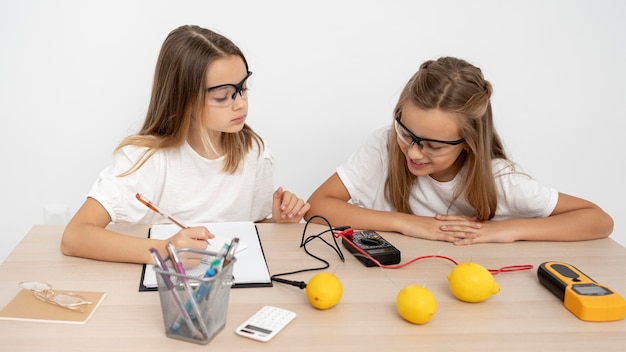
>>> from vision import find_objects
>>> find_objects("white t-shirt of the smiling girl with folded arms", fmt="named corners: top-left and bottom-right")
top-left (337, 128), bottom-right (559, 220)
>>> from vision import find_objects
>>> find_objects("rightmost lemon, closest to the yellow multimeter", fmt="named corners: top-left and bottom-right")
top-left (448, 262), bottom-right (500, 303)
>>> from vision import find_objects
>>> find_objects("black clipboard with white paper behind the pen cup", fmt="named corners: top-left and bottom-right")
top-left (139, 221), bottom-right (273, 292)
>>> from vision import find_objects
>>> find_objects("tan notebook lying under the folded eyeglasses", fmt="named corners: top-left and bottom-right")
top-left (0, 289), bottom-right (106, 324)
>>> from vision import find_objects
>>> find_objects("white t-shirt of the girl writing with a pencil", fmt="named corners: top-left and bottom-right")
top-left (88, 142), bottom-right (274, 224)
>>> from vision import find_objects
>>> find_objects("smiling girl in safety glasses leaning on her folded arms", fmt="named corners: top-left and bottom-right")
top-left (305, 57), bottom-right (613, 245)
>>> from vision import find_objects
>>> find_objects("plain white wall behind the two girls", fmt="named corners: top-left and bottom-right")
top-left (0, 0), bottom-right (626, 261)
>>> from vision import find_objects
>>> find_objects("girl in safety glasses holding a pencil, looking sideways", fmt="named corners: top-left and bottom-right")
top-left (61, 26), bottom-right (309, 263)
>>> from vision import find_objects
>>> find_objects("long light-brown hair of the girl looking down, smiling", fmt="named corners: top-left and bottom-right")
top-left (385, 57), bottom-right (507, 220)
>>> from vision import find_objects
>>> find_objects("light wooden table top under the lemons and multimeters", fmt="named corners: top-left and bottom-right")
top-left (0, 224), bottom-right (626, 352)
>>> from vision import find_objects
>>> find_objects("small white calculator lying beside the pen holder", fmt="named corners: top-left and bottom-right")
top-left (235, 306), bottom-right (296, 342)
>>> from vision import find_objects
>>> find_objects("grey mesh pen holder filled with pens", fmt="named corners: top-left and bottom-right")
top-left (154, 248), bottom-right (236, 344)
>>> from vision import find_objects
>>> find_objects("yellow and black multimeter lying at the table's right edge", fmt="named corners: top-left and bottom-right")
top-left (537, 262), bottom-right (626, 321)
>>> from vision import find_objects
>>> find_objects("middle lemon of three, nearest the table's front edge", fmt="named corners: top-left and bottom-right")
top-left (396, 285), bottom-right (437, 324)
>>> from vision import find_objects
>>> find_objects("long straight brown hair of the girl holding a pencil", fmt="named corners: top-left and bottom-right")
top-left (116, 25), bottom-right (263, 176)
